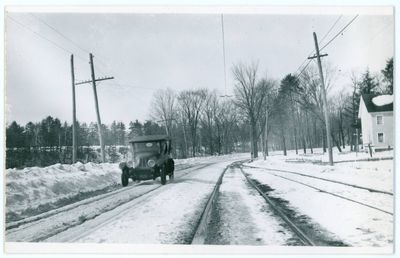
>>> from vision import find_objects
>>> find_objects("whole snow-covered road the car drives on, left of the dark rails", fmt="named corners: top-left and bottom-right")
top-left (6, 157), bottom-right (245, 243)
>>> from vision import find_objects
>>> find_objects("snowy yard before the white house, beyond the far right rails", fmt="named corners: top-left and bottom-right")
top-left (246, 149), bottom-right (394, 192)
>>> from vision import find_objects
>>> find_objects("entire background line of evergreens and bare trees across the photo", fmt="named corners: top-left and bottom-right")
top-left (6, 58), bottom-right (393, 167)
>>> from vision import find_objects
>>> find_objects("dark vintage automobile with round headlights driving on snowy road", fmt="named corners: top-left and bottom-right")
top-left (119, 135), bottom-right (174, 186)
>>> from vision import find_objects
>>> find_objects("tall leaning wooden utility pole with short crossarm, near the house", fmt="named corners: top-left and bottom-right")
top-left (308, 32), bottom-right (333, 166)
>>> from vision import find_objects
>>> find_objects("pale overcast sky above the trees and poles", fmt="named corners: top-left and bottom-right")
top-left (6, 6), bottom-right (394, 124)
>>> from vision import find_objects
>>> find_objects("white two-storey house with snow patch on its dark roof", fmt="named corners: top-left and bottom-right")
top-left (358, 94), bottom-right (394, 149)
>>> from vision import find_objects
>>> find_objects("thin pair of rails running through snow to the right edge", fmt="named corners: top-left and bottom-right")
top-left (242, 166), bottom-right (394, 216)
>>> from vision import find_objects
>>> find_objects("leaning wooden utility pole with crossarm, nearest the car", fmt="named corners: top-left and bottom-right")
top-left (75, 53), bottom-right (114, 163)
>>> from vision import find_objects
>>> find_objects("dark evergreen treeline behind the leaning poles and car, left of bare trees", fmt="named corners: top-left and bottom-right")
top-left (6, 116), bottom-right (165, 168)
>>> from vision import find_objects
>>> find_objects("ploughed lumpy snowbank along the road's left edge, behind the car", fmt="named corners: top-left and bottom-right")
top-left (6, 155), bottom-right (247, 220)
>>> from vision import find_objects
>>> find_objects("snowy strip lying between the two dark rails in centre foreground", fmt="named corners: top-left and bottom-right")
top-left (206, 168), bottom-right (293, 246)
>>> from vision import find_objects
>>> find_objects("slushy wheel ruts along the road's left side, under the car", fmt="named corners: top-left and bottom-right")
top-left (6, 163), bottom-right (214, 242)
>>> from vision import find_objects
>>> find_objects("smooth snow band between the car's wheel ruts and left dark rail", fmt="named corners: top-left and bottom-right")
top-left (46, 160), bottom-right (241, 244)
